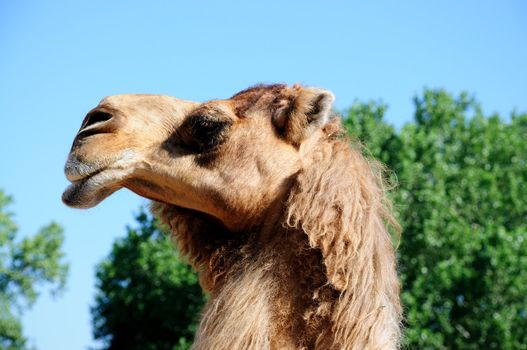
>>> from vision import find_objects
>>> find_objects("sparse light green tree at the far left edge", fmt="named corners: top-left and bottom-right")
top-left (0, 190), bottom-right (68, 350)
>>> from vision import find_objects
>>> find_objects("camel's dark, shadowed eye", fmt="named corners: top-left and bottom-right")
top-left (181, 115), bottom-right (232, 153)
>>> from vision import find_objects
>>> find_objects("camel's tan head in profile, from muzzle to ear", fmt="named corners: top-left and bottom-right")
top-left (62, 85), bottom-right (334, 230)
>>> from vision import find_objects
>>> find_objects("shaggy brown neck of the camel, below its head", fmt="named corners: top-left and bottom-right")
top-left (152, 118), bottom-right (401, 349)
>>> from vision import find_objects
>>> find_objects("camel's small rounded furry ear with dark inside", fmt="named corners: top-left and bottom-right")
top-left (273, 86), bottom-right (335, 146)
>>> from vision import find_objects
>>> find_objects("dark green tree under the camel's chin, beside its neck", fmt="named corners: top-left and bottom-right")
top-left (92, 211), bottom-right (204, 350)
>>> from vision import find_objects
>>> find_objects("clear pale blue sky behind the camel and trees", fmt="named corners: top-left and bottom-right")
top-left (0, 0), bottom-right (527, 350)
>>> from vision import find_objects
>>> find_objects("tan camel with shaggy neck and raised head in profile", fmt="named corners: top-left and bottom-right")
top-left (62, 84), bottom-right (401, 350)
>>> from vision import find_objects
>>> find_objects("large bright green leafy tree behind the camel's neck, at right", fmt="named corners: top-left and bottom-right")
top-left (346, 90), bottom-right (527, 349)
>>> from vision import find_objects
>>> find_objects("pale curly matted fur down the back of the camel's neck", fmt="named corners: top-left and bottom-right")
top-left (286, 120), bottom-right (401, 349)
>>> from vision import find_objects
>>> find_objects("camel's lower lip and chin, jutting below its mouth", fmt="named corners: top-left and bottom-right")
top-left (62, 170), bottom-right (122, 209)
